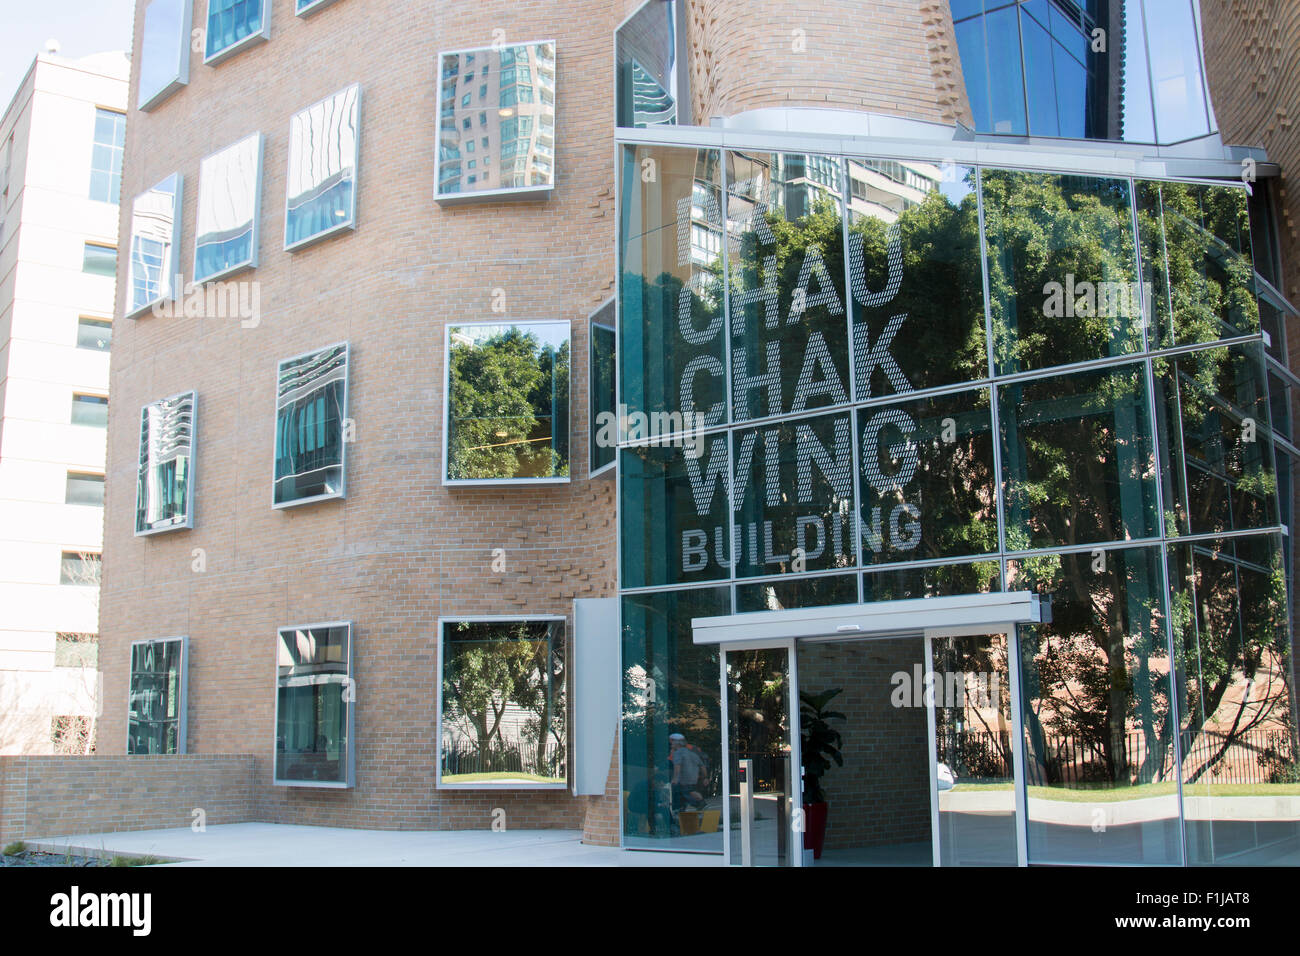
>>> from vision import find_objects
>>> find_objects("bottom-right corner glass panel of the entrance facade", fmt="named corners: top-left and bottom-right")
top-left (1169, 535), bottom-right (1300, 866)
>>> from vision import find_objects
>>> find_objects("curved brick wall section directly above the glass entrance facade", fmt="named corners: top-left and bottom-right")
top-left (686, 0), bottom-right (971, 125)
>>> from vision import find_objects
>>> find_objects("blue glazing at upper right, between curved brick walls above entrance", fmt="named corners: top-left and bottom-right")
top-left (950, 0), bottom-right (1216, 144)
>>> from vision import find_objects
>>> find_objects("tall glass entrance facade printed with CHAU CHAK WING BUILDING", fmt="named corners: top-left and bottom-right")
top-left (619, 143), bottom-right (1300, 864)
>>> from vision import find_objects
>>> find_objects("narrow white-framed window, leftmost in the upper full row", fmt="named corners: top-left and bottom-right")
top-left (122, 173), bottom-right (183, 319)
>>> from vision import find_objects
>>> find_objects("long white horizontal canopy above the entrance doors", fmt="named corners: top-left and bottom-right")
top-left (690, 591), bottom-right (1052, 644)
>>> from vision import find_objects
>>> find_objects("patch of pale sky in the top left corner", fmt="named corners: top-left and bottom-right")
top-left (0, 0), bottom-right (135, 112)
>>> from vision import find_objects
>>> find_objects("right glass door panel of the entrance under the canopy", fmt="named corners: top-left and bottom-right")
top-left (926, 633), bottom-right (1019, 866)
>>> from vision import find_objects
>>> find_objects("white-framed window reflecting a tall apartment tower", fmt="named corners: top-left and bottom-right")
top-left (434, 40), bottom-right (555, 204)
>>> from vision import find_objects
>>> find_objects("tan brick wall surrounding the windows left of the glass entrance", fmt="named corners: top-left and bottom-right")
top-left (99, 0), bottom-right (619, 829)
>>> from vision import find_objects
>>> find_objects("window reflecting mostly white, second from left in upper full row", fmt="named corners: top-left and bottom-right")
top-left (194, 133), bottom-right (263, 282)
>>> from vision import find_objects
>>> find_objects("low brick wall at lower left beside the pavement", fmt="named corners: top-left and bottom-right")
top-left (0, 754), bottom-right (256, 843)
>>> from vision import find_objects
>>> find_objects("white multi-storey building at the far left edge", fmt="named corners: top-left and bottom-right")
top-left (0, 53), bottom-right (130, 754)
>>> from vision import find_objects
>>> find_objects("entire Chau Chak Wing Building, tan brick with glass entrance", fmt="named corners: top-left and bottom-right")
top-left (100, 0), bottom-right (1300, 865)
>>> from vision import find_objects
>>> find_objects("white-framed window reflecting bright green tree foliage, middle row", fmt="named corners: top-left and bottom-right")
top-left (442, 320), bottom-right (571, 485)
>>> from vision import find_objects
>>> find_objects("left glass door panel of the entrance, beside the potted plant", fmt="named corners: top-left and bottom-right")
top-left (722, 641), bottom-right (803, 866)
